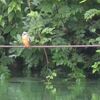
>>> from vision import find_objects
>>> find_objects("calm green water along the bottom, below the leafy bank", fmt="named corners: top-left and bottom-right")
top-left (0, 79), bottom-right (100, 100)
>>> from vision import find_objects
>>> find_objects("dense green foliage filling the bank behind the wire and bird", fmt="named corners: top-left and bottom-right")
top-left (0, 0), bottom-right (100, 79)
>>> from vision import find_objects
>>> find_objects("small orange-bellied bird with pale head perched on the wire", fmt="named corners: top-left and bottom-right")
top-left (22, 32), bottom-right (30, 48)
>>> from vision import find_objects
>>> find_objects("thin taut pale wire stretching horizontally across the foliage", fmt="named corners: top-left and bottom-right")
top-left (0, 45), bottom-right (100, 48)
